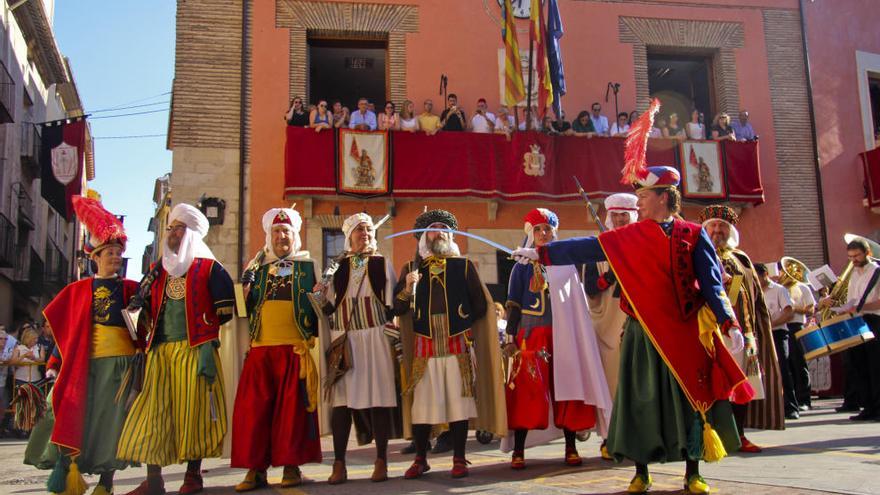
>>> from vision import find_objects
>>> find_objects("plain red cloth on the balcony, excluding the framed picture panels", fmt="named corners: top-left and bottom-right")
top-left (285, 126), bottom-right (764, 205)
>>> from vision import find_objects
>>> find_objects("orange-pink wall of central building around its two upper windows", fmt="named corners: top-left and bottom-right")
top-left (250, 0), bottom-right (797, 268)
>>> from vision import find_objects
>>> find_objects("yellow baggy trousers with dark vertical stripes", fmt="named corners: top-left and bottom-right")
top-left (117, 340), bottom-right (226, 466)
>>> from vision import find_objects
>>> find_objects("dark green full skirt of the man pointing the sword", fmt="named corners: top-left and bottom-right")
top-left (607, 318), bottom-right (740, 464)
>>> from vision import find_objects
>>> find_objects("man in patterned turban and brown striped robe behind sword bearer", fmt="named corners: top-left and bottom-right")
top-left (700, 205), bottom-right (785, 453)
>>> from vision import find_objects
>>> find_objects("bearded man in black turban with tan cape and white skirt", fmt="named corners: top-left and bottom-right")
top-left (394, 210), bottom-right (507, 479)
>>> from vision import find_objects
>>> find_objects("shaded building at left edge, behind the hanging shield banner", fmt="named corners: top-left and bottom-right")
top-left (0, 0), bottom-right (95, 327)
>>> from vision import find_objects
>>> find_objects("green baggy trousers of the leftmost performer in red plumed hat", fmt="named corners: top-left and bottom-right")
top-left (24, 356), bottom-right (134, 474)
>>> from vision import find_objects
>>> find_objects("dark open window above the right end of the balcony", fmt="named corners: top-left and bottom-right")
top-left (648, 49), bottom-right (716, 127)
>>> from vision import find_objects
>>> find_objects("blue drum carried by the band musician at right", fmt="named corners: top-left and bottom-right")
top-left (795, 315), bottom-right (874, 361)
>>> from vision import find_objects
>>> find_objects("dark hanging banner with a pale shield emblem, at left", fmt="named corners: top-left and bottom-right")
top-left (40, 118), bottom-right (86, 221)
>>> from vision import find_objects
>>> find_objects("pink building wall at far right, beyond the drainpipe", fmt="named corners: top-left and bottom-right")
top-left (804, 0), bottom-right (880, 270)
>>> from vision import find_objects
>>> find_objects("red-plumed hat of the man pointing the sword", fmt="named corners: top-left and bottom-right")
top-left (620, 98), bottom-right (681, 191)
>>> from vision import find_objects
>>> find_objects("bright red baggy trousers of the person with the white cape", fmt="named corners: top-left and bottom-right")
top-left (505, 326), bottom-right (596, 431)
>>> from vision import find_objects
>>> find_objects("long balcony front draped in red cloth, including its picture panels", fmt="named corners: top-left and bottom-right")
top-left (285, 126), bottom-right (764, 205)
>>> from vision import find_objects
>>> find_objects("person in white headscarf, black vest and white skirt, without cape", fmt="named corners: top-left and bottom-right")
top-left (316, 213), bottom-right (400, 485)
